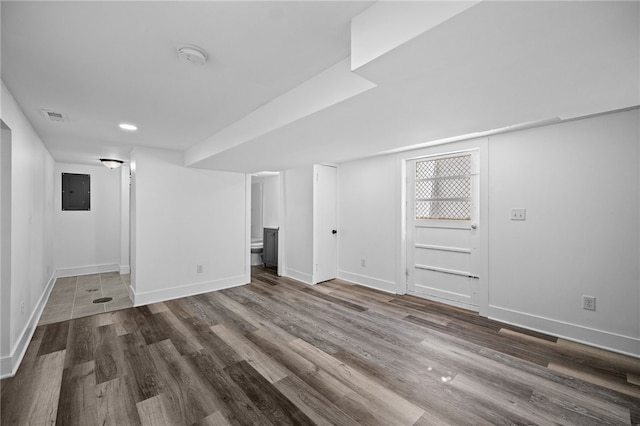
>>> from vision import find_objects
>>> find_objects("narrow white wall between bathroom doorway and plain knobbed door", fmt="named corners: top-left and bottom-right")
top-left (283, 166), bottom-right (313, 284)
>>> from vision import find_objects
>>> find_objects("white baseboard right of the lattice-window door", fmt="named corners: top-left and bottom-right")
top-left (488, 306), bottom-right (640, 358)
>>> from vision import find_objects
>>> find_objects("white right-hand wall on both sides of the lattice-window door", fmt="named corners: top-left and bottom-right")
top-left (338, 110), bottom-right (640, 355)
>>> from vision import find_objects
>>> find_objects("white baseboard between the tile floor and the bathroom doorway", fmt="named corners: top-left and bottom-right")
top-left (129, 275), bottom-right (249, 306)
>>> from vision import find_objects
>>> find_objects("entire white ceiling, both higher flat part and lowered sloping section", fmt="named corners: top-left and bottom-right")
top-left (2, 1), bottom-right (640, 172)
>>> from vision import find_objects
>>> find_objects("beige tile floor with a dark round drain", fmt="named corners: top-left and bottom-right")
top-left (38, 272), bottom-right (133, 325)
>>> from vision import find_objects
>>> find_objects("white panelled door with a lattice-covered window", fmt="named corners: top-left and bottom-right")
top-left (407, 151), bottom-right (480, 310)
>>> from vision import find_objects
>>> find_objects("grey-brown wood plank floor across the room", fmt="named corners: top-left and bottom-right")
top-left (1, 269), bottom-right (640, 426)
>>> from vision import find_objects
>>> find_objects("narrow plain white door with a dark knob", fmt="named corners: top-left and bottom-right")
top-left (313, 165), bottom-right (338, 284)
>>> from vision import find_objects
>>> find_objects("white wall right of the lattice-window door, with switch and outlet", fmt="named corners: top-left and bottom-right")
top-left (489, 110), bottom-right (640, 355)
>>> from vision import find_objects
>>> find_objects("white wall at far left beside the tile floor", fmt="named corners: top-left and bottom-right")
top-left (0, 83), bottom-right (54, 376)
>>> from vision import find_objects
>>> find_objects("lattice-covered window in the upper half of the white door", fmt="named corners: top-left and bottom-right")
top-left (416, 155), bottom-right (471, 220)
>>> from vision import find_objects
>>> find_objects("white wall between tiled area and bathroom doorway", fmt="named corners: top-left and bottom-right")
top-left (131, 148), bottom-right (250, 305)
